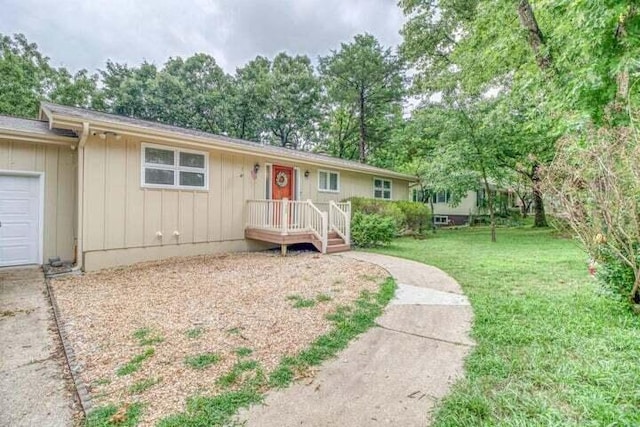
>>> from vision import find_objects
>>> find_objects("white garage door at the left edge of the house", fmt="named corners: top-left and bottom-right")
top-left (0, 175), bottom-right (41, 267)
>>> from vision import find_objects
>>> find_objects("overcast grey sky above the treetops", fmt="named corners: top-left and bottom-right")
top-left (0, 0), bottom-right (403, 73)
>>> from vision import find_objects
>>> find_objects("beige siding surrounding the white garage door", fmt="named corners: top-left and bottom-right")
top-left (0, 141), bottom-right (77, 262)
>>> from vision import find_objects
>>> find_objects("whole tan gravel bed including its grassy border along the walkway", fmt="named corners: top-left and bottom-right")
top-left (52, 253), bottom-right (394, 426)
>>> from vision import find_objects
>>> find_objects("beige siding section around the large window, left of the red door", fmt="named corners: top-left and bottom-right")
top-left (84, 137), bottom-right (264, 252)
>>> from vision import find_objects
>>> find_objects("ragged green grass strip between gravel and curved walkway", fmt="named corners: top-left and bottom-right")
top-left (158, 278), bottom-right (396, 427)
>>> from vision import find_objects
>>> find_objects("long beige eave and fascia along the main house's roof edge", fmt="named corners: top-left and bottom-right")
top-left (41, 112), bottom-right (416, 182)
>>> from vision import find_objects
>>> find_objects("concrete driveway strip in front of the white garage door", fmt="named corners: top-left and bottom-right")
top-left (0, 268), bottom-right (73, 426)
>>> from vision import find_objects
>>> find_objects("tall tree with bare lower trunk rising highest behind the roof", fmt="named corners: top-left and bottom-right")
top-left (320, 34), bottom-right (403, 163)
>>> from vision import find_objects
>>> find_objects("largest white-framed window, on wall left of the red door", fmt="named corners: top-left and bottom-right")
top-left (141, 144), bottom-right (209, 190)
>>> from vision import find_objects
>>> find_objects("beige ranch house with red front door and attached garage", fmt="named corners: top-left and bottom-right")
top-left (0, 103), bottom-right (413, 270)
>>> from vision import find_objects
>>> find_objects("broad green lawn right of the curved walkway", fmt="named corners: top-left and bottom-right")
top-left (378, 227), bottom-right (640, 426)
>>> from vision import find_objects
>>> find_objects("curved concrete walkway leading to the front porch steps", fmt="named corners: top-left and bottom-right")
top-left (240, 252), bottom-right (473, 427)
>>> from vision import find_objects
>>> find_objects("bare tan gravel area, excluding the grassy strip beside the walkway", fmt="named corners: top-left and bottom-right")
top-left (52, 253), bottom-right (388, 425)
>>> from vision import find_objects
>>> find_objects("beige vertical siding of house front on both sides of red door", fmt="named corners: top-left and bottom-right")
top-left (83, 136), bottom-right (409, 270)
